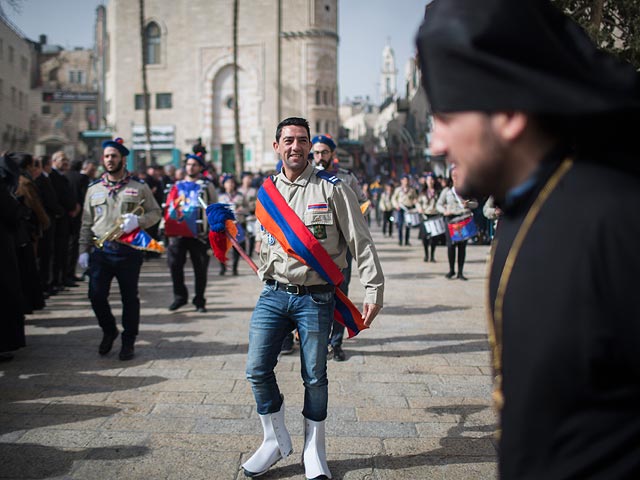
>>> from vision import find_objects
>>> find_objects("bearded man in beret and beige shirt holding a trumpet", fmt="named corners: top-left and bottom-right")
top-left (78, 138), bottom-right (161, 360)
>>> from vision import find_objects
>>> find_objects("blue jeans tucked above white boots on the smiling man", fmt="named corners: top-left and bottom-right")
top-left (247, 285), bottom-right (335, 422)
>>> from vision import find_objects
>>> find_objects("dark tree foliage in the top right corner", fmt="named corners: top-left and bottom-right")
top-left (552, 0), bottom-right (640, 69)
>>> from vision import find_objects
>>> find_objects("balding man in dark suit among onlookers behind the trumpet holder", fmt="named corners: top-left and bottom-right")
top-left (49, 151), bottom-right (80, 289)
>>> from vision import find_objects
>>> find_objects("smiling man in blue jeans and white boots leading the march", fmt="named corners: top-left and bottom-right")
top-left (242, 117), bottom-right (384, 478)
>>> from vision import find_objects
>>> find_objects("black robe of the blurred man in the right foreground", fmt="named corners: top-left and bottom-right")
top-left (490, 156), bottom-right (640, 480)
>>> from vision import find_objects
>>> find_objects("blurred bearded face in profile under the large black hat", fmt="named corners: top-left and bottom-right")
top-left (430, 112), bottom-right (506, 197)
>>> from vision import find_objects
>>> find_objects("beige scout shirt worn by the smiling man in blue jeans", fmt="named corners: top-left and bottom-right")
top-left (258, 164), bottom-right (384, 305)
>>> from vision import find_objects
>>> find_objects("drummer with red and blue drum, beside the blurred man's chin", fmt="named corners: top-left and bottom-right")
top-left (436, 167), bottom-right (478, 280)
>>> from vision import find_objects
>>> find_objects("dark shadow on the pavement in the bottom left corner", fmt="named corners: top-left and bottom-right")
top-left (0, 443), bottom-right (149, 479)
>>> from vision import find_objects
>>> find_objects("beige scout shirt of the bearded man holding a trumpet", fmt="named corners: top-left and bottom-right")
top-left (79, 176), bottom-right (162, 253)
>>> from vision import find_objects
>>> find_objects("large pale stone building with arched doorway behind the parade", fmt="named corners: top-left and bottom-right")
top-left (105, 0), bottom-right (338, 172)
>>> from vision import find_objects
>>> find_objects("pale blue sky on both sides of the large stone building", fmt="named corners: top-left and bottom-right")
top-left (5, 0), bottom-right (427, 103)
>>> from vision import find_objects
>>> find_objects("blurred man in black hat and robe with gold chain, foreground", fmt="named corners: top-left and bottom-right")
top-left (417, 0), bottom-right (640, 480)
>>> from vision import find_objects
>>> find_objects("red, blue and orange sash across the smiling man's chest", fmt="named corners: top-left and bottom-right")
top-left (256, 178), bottom-right (369, 338)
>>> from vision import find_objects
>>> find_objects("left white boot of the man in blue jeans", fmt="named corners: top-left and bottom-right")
top-left (242, 400), bottom-right (293, 477)
